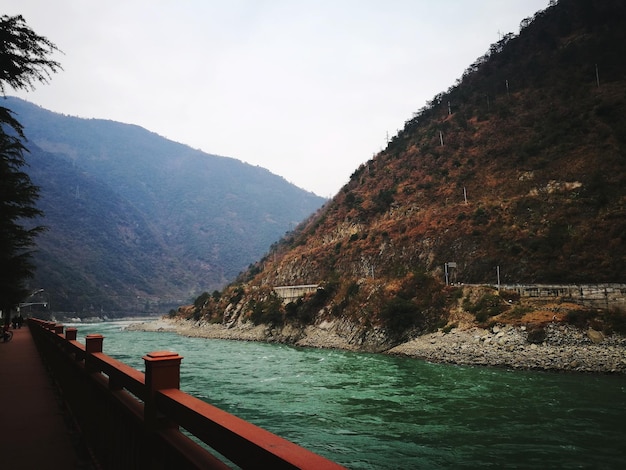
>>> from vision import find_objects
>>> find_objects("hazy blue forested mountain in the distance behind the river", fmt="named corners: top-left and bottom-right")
top-left (3, 98), bottom-right (324, 315)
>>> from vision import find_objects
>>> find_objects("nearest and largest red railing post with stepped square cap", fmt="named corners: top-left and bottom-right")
top-left (143, 351), bottom-right (183, 429)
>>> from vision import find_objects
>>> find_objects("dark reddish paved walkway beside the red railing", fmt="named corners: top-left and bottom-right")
top-left (0, 326), bottom-right (93, 470)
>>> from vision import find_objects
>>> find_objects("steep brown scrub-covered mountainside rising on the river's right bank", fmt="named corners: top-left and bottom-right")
top-left (183, 0), bottom-right (626, 345)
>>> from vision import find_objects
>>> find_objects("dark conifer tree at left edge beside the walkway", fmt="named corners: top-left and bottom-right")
top-left (0, 15), bottom-right (61, 324)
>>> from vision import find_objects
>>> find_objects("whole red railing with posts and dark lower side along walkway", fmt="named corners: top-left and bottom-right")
top-left (29, 319), bottom-right (343, 470)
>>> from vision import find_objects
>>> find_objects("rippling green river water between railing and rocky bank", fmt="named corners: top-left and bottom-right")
top-left (67, 321), bottom-right (626, 470)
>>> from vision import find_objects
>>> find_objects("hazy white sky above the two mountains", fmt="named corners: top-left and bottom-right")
top-left (0, 0), bottom-right (548, 197)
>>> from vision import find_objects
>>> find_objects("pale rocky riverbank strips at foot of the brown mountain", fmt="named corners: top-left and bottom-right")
top-left (128, 319), bottom-right (626, 374)
